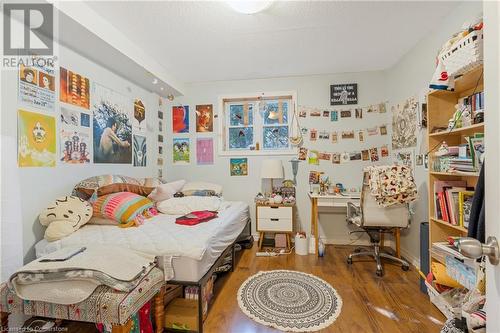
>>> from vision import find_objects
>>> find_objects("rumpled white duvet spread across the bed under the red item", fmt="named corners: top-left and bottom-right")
top-left (35, 202), bottom-right (248, 260)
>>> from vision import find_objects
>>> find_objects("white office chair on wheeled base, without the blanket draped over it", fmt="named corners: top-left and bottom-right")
top-left (347, 172), bottom-right (411, 276)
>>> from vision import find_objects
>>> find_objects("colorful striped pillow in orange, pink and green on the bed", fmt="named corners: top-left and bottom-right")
top-left (94, 192), bottom-right (158, 228)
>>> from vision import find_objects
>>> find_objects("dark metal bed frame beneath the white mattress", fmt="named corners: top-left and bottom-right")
top-left (165, 218), bottom-right (252, 333)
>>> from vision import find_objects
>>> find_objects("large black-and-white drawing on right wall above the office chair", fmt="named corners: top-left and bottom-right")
top-left (392, 97), bottom-right (418, 150)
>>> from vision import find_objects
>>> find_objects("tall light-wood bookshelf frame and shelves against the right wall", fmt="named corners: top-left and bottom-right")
top-left (427, 65), bottom-right (484, 270)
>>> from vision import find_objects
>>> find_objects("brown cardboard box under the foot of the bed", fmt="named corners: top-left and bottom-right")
top-left (165, 298), bottom-right (198, 331)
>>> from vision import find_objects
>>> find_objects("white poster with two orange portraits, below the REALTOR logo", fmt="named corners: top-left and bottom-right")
top-left (18, 60), bottom-right (56, 111)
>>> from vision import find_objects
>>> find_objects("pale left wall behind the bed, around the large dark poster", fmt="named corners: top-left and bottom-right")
top-left (1, 40), bottom-right (158, 278)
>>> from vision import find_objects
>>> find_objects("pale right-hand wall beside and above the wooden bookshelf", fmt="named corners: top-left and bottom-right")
top-left (385, 1), bottom-right (484, 263)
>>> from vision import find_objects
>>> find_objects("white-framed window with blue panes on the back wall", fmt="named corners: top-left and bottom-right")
top-left (219, 93), bottom-right (295, 155)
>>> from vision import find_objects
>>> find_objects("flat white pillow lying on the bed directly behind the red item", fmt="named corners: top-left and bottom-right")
top-left (156, 196), bottom-right (222, 215)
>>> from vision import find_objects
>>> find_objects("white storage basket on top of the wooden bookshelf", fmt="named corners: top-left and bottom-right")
top-left (439, 29), bottom-right (483, 77)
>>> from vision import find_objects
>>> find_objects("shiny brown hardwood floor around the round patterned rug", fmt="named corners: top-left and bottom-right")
top-left (204, 246), bottom-right (445, 333)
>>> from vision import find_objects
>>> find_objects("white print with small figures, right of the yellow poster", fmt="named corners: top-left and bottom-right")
top-left (59, 124), bottom-right (92, 164)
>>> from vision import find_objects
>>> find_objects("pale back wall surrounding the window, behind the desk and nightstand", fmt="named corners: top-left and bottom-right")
top-left (164, 72), bottom-right (390, 244)
